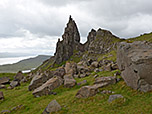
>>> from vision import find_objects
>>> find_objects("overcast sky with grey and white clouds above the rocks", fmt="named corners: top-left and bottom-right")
top-left (0, 0), bottom-right (152, 55)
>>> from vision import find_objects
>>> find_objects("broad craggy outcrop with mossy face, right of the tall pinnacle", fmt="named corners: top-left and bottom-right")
top-left (88, 29), bottom-right (119, 54)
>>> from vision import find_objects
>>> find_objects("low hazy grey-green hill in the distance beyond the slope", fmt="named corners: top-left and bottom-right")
top-left (0, 55), bottom-right (50, 73)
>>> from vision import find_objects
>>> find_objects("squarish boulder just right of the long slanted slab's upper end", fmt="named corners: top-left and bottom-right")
top-left (64, 75), bottom-right (76, 88)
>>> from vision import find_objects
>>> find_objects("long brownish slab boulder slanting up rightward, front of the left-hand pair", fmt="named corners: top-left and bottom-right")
top-left (33, 77), bottom-right (63, 97)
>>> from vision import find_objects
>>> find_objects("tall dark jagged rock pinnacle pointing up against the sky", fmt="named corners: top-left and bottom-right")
top-left (54, 16), bottom-right (83, 64)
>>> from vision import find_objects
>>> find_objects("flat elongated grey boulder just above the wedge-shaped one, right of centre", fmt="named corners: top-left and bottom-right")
top-left (94, 76), bottom-right (117, 85)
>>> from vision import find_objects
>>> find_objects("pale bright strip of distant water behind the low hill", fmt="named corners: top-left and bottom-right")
top-left (0, 56), bottom-right (35, 65)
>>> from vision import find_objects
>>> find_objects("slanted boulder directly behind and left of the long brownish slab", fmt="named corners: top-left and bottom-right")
top-left (28, 73), bottom-right (48, 91)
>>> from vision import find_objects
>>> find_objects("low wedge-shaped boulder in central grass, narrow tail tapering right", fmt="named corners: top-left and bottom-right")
top-left (76, 83), bottom-right (107, 98)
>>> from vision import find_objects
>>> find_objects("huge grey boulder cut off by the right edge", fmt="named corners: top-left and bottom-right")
top-left (117, 41), bottom-right (152, 92)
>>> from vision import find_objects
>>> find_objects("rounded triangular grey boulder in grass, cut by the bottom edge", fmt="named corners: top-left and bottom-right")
top-left (43, 100), bottom-right (61, 114)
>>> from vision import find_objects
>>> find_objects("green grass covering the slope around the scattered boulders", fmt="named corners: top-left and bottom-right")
top-left (0, 35), bottom-right (152, 114)
